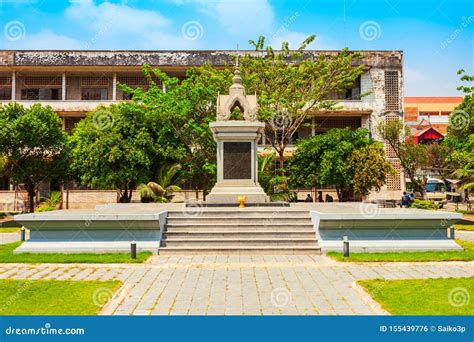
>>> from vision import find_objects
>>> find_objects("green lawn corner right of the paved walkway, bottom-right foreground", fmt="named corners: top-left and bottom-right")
top-left (358, 277), bottom-right (474, 315)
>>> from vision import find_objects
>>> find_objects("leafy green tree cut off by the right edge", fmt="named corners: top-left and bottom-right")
top-left (443, 70), bottom-right (474, 188)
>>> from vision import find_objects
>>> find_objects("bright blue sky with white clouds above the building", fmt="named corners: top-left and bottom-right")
top-left (0, 0), bottom-right (474, 96)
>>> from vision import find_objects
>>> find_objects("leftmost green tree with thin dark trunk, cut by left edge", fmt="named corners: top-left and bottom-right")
top-left (0, 103), bottom-right (69, 212)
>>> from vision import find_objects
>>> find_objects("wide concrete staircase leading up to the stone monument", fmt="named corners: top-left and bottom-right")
top-left (159, 208), bottom-right (321, 255)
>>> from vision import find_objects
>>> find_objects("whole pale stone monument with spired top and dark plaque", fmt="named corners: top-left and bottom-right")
top-left (206, 69), bottom-right (270, 204)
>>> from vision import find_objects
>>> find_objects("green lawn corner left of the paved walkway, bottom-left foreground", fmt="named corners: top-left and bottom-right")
top-left (0, 279), bottom-right (121, 315)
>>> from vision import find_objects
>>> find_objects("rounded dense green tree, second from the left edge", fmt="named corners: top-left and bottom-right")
top-left (69, 102), bottom-right (156, 202)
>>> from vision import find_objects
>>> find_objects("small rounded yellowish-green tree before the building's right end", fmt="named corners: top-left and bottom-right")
top-left (348, 142), bottom-right (395, 196)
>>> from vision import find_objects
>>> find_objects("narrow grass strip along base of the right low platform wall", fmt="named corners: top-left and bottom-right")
top-left (327, 240), bottom-right (474, 262)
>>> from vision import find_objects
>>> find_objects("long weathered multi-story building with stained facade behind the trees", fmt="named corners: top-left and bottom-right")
top-left (0, 51), bottom-right (404, 206)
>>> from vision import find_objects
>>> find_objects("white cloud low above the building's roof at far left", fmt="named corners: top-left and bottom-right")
top-left (5, 30), bottom-right (83, 50)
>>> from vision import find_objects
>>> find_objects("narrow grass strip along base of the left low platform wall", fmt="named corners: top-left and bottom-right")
top-left (0, 241), bottom-right (152, 264)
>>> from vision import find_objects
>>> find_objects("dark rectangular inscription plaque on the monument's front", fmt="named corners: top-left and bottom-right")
top-left (224, 141), bottom-right (252, 179)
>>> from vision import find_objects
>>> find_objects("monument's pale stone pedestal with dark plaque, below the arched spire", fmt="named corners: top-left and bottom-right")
top-left (206, 120), bottom-right (270, 203)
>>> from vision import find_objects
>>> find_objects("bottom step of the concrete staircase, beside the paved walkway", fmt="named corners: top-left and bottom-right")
top-left (158, 246), bottom-right (321, 255)
